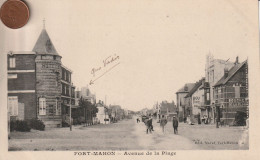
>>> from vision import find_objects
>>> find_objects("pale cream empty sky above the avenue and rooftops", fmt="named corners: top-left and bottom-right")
top-left (0, 0), bottom-right (256, 111)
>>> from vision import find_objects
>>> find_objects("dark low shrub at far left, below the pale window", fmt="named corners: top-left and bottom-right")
top-left (10, 120), bottom-right (31, 132)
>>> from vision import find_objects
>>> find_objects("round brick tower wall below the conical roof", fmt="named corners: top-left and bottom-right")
top-left (35, 55), bottom-right (61, 117)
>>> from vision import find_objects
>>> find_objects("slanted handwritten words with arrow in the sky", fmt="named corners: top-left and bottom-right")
top-left (89, 54), bottom-right (120, 85)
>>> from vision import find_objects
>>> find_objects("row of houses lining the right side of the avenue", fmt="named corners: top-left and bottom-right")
top-left (176, 54), bottom-right (248, 125)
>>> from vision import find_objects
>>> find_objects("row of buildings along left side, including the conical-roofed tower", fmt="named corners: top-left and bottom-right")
top-left (7, 28), bottom-right (130, 127)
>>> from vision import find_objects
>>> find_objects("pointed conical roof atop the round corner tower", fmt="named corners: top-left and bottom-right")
top-left (33, 29), bottom-right (59, 56)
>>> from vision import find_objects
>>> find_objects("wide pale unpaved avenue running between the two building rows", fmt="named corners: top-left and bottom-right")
top-left (9, 118), bottom-right (249, 151)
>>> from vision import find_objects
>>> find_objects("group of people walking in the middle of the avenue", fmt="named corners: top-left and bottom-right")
top-left (136, 115), bottom-right (179, 134)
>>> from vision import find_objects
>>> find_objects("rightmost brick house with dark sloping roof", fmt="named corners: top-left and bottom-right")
top-left (214, 61), bottom-right (248, 125)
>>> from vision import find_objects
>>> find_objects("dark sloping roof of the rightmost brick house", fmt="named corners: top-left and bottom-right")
top-left (214, 60), bottom-right (247, 87)
